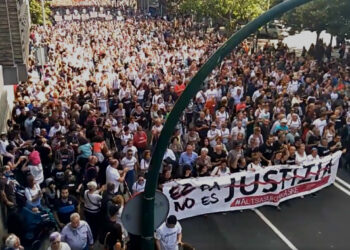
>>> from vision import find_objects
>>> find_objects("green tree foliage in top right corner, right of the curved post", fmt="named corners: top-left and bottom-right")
top-left (283, 0), bottom-right (350, 37)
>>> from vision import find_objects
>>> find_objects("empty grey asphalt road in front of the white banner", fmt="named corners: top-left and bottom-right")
top-left (181, 169), bottom-right (350, 250)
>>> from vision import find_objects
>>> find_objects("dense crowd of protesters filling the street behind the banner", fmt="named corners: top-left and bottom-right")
top-left (0, 5), bottom-right (350, 250)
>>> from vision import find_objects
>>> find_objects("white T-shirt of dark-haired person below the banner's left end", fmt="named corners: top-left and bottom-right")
top-left (155, 222), bottom-right (182, 250)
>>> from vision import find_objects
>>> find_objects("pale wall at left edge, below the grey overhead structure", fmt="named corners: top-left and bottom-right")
top-left (0, 65), bottom-right (15, 132)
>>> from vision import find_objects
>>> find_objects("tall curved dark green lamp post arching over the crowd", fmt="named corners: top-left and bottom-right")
top-left (141, 0), bottom-right (312, 250)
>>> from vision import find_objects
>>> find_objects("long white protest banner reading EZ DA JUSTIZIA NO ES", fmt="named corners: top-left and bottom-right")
top-left (163, 151), bottom-right (342, 219)
